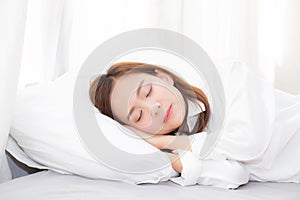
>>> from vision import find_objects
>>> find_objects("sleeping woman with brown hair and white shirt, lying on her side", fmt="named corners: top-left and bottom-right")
top-left (90, 62), bottom-right (300, 188)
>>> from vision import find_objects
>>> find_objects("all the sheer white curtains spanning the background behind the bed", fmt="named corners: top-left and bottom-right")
top-left (0, 0), bottom-right (300, 181)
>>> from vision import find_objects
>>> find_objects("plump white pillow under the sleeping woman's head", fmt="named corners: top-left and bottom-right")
top-left (8, 67), bottom-right (174, 183)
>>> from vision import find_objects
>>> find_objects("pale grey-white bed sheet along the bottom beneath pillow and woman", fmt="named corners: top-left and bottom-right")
top-left (0, 171), bottom-right (300, 200)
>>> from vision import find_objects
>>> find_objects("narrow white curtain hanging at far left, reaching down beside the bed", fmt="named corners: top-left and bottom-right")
top-left (0, 0), bottom-right (27, 182)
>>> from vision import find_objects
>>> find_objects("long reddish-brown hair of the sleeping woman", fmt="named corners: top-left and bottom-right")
top-left (89, 62), bottom-right (210, 134)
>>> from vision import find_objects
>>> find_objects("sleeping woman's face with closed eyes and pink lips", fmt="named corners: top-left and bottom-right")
top-left (111, 71), bottom-right (185, 134)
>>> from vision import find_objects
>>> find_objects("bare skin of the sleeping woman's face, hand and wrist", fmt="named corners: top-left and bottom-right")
top-left (111, 70), bottom-right (191, 173)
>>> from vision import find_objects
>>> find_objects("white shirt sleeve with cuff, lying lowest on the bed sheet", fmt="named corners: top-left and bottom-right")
top-left (170, 149), bottom-right (250, 189)
